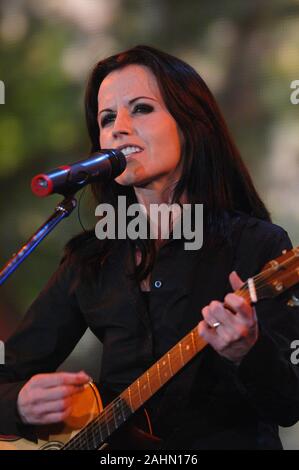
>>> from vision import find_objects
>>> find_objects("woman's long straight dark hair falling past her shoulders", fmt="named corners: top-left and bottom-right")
top-left (67, 46), bottom-right (270, 280)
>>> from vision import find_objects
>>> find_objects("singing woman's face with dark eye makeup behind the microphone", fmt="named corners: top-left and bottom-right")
top-left (98, 65), bottom-right (182, 189)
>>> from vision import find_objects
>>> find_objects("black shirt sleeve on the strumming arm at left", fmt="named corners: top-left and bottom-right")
top-left (0, 263), bottom-right (87, 439)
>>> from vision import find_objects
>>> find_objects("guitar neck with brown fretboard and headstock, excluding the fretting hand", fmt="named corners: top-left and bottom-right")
top-left (64, 247), bottom-right (299, 449)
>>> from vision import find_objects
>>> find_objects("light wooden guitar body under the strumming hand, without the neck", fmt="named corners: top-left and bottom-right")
top-left (0, 383), bottom-right (160, 450)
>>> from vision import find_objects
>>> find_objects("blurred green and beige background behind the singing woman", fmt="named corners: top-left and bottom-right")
top-left (0, 0), bottom-right (299, 449)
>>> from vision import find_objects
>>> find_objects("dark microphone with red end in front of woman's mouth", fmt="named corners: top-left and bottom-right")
top-left (31, 149), bottom-right (127, 197)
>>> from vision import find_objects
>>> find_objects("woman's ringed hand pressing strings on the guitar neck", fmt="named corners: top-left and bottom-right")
top-left (198, 271), bottom-right (258, 364)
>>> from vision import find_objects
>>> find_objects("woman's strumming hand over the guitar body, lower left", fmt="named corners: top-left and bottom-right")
top-left (17, 372), bottom-right (91, 424)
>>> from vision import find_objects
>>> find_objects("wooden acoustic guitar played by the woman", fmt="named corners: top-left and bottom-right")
top-left (0, 247), bottom-right (299, 450)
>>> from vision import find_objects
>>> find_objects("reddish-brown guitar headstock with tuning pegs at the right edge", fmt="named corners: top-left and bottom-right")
top-left (253, 247), bottom-right (299, 299)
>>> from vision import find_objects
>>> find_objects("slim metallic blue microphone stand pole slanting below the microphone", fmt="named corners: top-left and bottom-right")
top-left (0, 194), bottom-right (77, 286)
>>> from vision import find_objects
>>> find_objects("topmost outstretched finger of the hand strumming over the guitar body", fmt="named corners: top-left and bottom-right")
top-left (30, 371), bottom-right (91, 388)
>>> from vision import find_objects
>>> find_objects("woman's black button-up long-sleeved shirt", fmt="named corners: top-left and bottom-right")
top-left (0, 214), bottom-right (299, 449)
